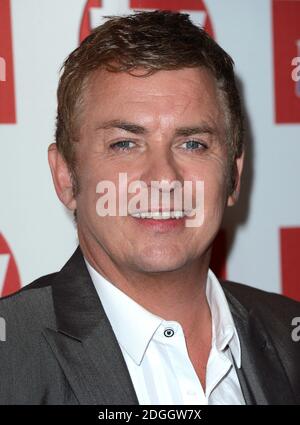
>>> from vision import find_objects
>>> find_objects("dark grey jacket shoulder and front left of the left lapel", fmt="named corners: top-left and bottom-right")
top-left (0, 273), bottom-right (76, 405)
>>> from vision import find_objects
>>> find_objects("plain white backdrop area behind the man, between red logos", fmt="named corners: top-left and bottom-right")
top-left (0, 0), bottom-right (300, 297)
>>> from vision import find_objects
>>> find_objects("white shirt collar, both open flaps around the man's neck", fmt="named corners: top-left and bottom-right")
top-left (85, 259), bottom-right (241, 368)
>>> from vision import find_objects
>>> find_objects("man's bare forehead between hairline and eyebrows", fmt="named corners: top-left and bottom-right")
top-left (84, 68), bottom-right (223, 125)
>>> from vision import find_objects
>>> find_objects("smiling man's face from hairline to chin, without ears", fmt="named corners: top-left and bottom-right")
top-left (60, 68), bottom-right (241, 273)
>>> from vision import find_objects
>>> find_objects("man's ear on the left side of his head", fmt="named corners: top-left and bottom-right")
top-left (48, 143), bottom-right (76, 211)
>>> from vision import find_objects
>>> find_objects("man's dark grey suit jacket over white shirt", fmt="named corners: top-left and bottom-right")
top-left (0, 248), bottom-right (300, 404)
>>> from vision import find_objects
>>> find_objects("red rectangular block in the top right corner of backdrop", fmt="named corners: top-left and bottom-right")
top-left (274, 0), bottom-right (300, 123)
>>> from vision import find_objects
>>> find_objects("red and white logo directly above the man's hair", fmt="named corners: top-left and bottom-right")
top-left (79, 0), bottom-right (214, 42)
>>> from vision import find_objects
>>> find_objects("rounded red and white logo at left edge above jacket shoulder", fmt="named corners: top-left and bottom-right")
top-left (0, 233), bottom-right (21, 297)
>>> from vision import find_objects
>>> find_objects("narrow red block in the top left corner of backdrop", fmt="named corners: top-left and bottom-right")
top-left (0, 0), bottom-right (16, 124)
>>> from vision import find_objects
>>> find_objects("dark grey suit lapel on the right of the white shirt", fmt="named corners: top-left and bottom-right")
top-left (223, 286), bottom-right (296, 405)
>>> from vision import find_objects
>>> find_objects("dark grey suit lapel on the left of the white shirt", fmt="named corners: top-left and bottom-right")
top-left (44, 248), bottom-right (138, 404)
